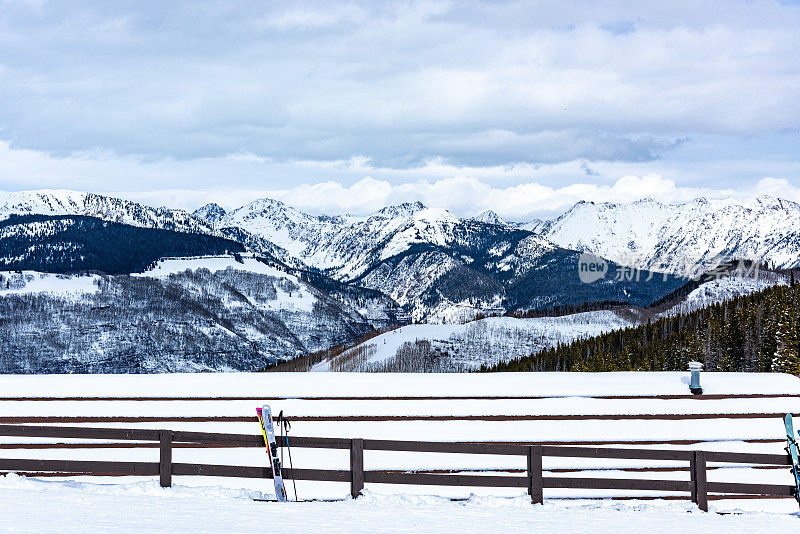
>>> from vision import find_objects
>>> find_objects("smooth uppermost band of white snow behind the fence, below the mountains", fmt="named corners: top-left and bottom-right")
top-left (0, 371), bottom-right (800, 400)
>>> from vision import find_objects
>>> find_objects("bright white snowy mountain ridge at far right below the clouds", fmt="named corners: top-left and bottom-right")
top-left (530, 196), bottom-right (800, 277)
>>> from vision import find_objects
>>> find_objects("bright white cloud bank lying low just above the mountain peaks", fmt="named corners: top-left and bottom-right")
top-left (0, 142), bottom-right (800, 220)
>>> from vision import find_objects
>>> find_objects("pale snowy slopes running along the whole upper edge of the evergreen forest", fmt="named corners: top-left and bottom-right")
top-left (315, 270), bottom-right (788, 372)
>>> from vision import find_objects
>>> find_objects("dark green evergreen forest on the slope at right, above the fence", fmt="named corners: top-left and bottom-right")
top-left (481, 277), bottom-right (800, 375)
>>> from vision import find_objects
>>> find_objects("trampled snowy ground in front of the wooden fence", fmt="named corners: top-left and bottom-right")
top-left (0, 477), bottom-right (800, 534)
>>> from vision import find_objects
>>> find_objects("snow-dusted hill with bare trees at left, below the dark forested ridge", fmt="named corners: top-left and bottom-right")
top-left (0, 255), bottom-right (382, 373)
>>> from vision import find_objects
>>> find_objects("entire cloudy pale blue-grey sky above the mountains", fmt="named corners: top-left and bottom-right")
top-left (0, 0), bottom-right (800, 219)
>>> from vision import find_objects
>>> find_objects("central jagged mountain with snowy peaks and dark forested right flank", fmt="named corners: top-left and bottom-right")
top-left (194, 199), bottom-right (682, 322)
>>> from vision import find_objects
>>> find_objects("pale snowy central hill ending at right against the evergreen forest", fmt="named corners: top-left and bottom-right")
top-left (320, 310), bottom-right (635, 372)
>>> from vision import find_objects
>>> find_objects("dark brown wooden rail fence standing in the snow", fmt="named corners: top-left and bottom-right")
top-left (0, 425), bottom-right (794, 511)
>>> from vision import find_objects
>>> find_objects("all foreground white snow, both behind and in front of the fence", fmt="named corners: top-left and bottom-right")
top-left (0, 373), bottom-right (800, 533)
